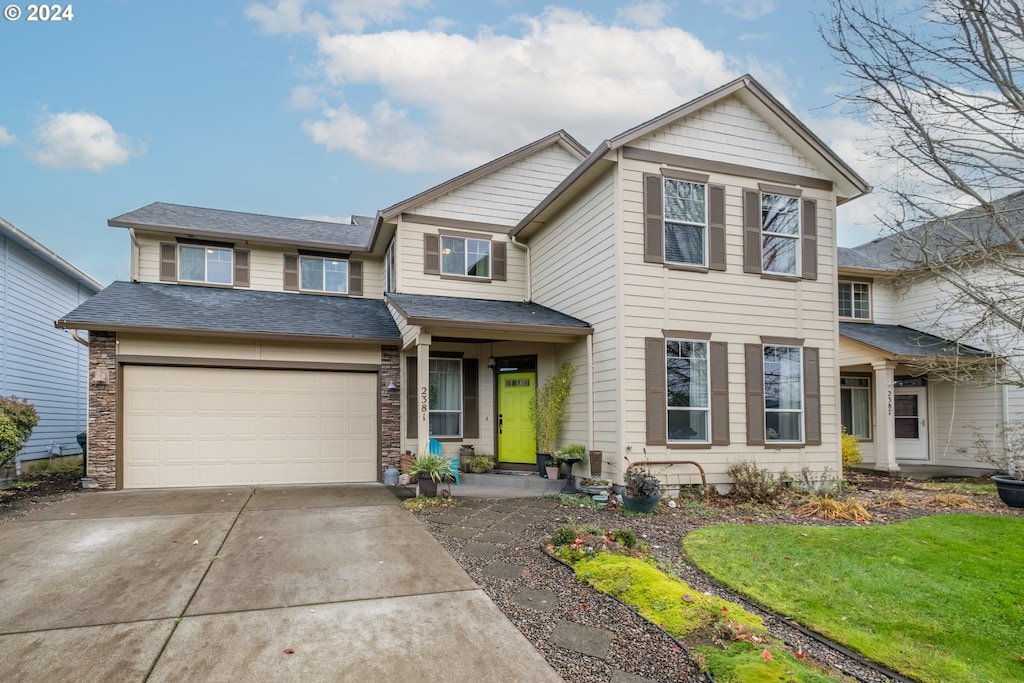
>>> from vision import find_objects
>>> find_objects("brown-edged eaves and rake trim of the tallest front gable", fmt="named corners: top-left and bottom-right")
top-left (512, 75), bottom-right (871, 234)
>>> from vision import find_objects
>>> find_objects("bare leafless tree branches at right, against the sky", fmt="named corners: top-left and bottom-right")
top-left (820, 0), bottom-right (1024, 386)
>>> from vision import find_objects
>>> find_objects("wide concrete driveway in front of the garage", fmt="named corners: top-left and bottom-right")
top-left (0, 484), bottom-right (561, 683)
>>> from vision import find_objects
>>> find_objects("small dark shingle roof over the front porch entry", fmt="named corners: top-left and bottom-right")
top-left (388, 294), bottom-right (590, 333)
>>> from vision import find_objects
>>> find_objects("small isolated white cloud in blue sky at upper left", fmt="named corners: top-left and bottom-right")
top-left (31, 112), bottom-right (145, 171)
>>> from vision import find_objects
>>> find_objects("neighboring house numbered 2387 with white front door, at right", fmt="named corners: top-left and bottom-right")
top-left (839, 194), bottom-right (1024, 473)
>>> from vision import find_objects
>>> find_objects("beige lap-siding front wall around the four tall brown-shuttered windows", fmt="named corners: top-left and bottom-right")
top-left (620, 152), bottom-right (840, 482)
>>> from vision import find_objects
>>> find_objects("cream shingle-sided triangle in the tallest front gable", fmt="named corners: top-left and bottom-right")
top-left (633, 97), bottom-right (825, 184)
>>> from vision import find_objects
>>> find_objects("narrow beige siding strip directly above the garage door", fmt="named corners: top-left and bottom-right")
top-left (118, 334), bottom-right (381, 365)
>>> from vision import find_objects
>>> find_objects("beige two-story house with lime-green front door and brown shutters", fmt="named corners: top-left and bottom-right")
top-left (58, 77), bottom-right (869, 487)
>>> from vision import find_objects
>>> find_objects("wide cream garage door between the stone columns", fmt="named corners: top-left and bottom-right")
top-left (123, 366), bottom-right (378, 488)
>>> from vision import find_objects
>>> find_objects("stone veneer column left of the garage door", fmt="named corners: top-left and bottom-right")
top-left (85, 332), bottom-right (120, 489)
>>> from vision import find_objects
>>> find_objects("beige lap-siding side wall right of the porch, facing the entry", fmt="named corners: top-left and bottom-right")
top-left (530, 167), bottom-right (622, 471)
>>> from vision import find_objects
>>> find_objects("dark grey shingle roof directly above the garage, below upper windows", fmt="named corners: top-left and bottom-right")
top-left (57, 282), bottom-right (401, 340)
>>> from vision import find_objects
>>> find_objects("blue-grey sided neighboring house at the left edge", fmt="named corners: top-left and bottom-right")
top-left (0, 218), bottom-right (102, 461)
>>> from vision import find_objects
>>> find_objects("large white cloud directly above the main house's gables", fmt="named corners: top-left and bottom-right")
top-left (280, 8), bottom-right (746, 171)
